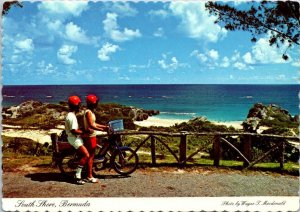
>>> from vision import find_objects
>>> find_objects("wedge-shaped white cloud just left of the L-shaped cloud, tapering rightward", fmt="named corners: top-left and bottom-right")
top-left (66, 22), bottom-right (97, 44)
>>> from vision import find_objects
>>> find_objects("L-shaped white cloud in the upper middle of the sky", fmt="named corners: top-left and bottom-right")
top-left (103, 13), bottom-right (141, 42)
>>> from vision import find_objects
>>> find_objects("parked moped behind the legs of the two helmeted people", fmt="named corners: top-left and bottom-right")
top-left (51, 134), bottom-right (139, 177)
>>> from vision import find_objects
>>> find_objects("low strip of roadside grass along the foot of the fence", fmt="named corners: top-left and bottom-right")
top-left (2, 147), bottom-right (299, 176)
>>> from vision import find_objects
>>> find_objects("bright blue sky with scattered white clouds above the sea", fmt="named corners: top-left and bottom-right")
top-left (2, 1), bottom-right (300, 85)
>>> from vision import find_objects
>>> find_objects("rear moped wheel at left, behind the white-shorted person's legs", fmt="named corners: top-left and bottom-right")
top-left (58, 155), bottom-right (78, 177)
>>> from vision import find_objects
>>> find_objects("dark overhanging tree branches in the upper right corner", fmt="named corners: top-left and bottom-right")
top-left (205, 1), bottom-right (300, 60)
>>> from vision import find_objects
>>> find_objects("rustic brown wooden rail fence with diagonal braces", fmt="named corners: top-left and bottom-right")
top-left (99, 131), bottom-right (299, 169)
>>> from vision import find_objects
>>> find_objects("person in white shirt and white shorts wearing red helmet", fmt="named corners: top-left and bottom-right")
top-left (65, 96), bottom-right (90, 185)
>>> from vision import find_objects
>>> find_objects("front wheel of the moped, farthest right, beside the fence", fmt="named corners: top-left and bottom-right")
top-left (110, 147), bottom-right (139, 175)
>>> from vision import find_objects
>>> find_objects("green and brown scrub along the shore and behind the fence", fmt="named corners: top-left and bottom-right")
top-left (2, 102), bottom-right (299, 176)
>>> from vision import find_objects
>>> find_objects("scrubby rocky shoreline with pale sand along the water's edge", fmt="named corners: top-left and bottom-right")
top-left (2, 100), bottom-right (299, 135)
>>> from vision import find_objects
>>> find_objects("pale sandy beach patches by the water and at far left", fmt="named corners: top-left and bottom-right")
top-left (1, 117), bottom-right (242, 143)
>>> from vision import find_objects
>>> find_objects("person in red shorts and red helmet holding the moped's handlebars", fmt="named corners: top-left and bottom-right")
top-left (83, 94), bottom-right (109, 183)
